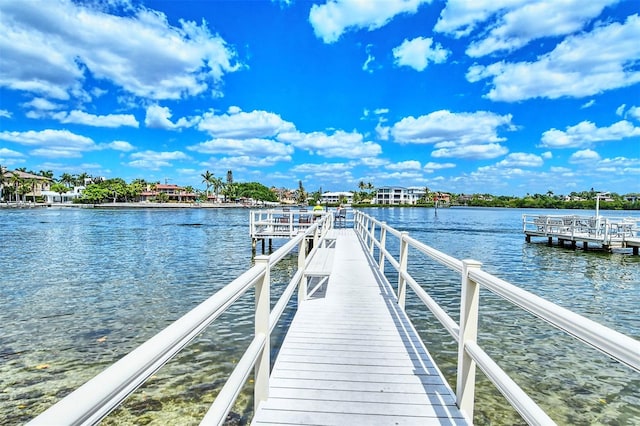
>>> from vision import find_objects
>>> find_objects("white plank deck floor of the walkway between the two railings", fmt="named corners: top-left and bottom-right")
top-left (253, 229), bottom-right (468, 425)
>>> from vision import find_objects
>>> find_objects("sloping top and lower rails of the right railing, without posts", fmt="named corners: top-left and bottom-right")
top-left (354, 212), bottom-right (640, 425)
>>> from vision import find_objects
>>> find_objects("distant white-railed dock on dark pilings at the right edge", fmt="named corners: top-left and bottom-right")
top-left (522, 214), bottom-right (640, 255)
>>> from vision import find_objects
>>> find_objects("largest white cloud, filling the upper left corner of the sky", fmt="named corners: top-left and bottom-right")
top-left (0, 0), bottom-right (239, 100)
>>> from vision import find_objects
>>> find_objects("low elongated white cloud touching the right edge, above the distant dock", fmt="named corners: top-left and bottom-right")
top-left (541, 120), bottom-right (640, 148)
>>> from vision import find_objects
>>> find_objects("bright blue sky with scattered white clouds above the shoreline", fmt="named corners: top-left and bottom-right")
top-left (0, 0), bottom-right (640, 196)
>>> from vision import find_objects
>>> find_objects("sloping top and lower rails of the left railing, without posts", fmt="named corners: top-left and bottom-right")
top-left (29, 215), bottom-right (333, 425)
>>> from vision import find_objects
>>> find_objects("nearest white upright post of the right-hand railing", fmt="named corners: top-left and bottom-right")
top-left (456, 259), bottom-right (482, 420)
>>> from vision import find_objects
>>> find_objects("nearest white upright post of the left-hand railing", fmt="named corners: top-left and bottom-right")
top-left (253, 255), bottom-right (271, 411)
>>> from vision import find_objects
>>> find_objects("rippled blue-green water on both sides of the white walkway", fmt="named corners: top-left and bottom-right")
top-left (0, 208), bottom-right (640, 424)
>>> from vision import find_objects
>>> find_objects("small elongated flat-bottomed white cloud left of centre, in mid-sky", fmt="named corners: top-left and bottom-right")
top-left (198, 109), bottom-right (294, 139)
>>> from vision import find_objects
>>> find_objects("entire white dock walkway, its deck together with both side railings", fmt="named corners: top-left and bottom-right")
top-left (29, 210), bottom-right (640, 425)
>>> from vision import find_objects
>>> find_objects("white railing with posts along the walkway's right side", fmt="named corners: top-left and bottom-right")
top-left (354, 211), bottom-right (640, 425)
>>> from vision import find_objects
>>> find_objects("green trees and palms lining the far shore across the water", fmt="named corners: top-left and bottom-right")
top-left (0, 166), bottom-right (640, 210)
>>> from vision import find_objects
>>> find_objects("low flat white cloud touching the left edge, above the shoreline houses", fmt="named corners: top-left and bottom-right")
top-left (0, 129), bottom-right (100, 158)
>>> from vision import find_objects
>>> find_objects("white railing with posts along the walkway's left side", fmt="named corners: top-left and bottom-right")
top-left (29, 214), bottom-right (333, 425)
